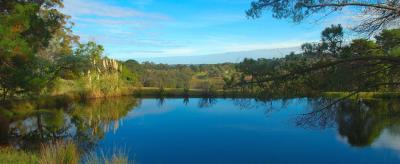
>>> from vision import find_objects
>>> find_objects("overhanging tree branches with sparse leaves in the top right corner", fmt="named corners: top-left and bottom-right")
top-left (246, 0), bottom-right (400, 34)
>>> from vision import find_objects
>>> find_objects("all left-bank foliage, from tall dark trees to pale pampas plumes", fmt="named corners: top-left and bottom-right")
top-left (0, 0), bottom-right (138, 101)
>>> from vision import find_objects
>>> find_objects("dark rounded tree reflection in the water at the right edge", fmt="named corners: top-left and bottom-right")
top-left (296, 99), bottom-right (400, 147)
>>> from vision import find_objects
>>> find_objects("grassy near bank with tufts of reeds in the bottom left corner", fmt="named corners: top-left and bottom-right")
top-left (0, 142), bottom-right (129, 164)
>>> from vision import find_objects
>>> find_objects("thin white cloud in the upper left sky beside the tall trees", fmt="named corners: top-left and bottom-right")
top-left (62, 0), bottom-right (170, 51)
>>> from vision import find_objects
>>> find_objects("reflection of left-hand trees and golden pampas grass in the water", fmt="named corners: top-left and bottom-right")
top-left (0, 98), bottom-right (138, 149)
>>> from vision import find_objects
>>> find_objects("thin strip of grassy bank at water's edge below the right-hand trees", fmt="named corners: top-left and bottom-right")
top-left (323, 92), bottom-right (400, 99)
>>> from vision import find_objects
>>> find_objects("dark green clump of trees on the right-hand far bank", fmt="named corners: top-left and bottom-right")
top-left (234, 25), bottom-right (400, 96)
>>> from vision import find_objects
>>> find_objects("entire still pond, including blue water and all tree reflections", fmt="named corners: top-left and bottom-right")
top-left (0, 98), bottom-right (400, 164)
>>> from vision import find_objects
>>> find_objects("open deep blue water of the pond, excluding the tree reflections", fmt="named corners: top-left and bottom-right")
top-left (92, 98), bottom-right (400, 164)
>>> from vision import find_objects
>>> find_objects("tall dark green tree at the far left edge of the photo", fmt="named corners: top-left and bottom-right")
top-left (0, 0), bottom-right (72, 100)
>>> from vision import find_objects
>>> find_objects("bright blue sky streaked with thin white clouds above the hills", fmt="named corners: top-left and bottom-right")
top-left (63, 0), bottom-right (350, 59)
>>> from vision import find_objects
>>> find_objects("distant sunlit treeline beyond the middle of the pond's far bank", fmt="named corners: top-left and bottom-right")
top-left (123, 60), bottom-right (235, 89)
